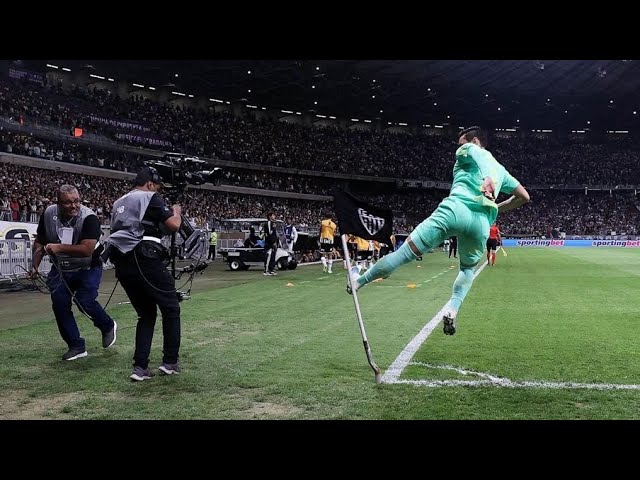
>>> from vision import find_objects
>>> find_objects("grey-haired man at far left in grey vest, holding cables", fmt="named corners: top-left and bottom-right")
top-left (29, 185), bottom-right (118, 360)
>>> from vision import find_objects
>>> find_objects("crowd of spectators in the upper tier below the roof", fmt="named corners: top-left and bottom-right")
top-left (0, 80), bottom-right (640, 185)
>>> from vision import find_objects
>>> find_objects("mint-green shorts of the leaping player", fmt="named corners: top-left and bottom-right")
top-left (410, 197), bottom-right (490, 267)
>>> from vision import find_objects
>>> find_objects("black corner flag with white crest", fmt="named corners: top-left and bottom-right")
top-left (333, 190), bottom-right (393, 245)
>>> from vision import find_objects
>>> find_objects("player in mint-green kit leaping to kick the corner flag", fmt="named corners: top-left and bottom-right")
top-left (347, 127), bottom-right (529, 335)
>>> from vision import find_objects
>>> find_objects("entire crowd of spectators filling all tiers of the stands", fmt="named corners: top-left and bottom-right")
top-left (0, 76), bottom-right (640, 235)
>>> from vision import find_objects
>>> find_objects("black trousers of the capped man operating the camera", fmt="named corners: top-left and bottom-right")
top-left (113, 248), bottom-right (180, 368)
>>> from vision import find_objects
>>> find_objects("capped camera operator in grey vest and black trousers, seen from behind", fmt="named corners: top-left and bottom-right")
top-left (106, 167), bottom-right (182, 381)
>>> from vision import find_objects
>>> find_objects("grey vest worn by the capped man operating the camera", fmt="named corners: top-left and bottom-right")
top-left (105, 190), bottom-right (155, 253)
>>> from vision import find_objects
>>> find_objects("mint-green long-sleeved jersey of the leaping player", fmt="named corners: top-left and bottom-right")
top-left (449, 142), bottom-right (520, 224)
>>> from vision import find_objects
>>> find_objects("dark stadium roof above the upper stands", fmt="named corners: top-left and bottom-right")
top-left (33, 60), bottom-right (640, 130)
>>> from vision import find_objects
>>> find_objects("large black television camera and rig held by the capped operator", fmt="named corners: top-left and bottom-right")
top-left (145, 153), bottom-right (222, 280)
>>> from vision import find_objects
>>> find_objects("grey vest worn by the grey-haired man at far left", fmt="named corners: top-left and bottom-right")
top-left (43, 205), bottom-right (95, 272)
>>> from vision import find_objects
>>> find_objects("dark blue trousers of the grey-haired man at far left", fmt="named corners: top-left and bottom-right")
top-left (47, 266), bottom-right (113, 349)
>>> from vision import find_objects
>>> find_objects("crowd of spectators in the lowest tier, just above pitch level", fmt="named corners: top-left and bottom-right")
top-left (0, 163), bottom-right (640, 235)
